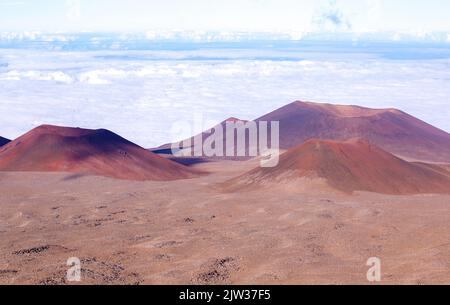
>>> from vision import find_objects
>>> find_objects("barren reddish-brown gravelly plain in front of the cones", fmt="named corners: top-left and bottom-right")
top-left (0, 161), bottom-right (450, 284)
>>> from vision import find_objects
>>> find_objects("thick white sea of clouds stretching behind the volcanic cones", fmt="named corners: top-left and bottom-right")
top-left (0, 43), bottom-right (450, 147)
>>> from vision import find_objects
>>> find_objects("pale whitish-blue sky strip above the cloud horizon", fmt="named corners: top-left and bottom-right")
top-left (0, 0), bottom-right (450, 33)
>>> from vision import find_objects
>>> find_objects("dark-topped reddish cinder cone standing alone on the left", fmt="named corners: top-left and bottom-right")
top-left (0, 125), bottom-right (196, 181)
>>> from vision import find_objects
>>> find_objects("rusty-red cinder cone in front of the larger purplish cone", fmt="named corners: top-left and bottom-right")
top-left (230, 140), bottom-right (450, 195)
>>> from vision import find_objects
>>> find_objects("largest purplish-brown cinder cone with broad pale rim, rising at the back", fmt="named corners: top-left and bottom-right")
top-left (256, 102), bottom-right (450, 162)
